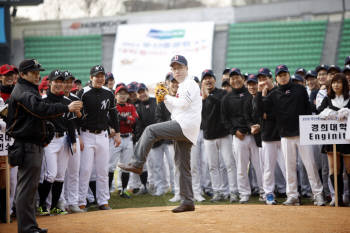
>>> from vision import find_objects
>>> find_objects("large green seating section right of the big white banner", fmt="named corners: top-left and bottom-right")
top-left (226, 21), bottom-right (326, 73)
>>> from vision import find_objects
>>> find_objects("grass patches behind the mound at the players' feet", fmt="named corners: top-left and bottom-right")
top-left (88, 192), bottom-right (313, 211)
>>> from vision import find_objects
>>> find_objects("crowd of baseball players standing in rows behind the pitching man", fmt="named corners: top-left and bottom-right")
top-left (0, 56), bottom-right (350, 223)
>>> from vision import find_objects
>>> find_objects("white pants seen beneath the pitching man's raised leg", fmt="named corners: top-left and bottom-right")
top-left (147, 146), bottom-right (169, 193)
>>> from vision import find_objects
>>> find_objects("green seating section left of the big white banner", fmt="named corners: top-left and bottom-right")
top-left (24, 35), bottom-right (102, 83)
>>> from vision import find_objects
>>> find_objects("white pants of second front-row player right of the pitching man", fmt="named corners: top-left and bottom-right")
top-left (233, 135), bottom-right (263, 196)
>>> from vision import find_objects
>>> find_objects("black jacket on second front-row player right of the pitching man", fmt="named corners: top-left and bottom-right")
top-left (221, 86), bottom-right (251, 135)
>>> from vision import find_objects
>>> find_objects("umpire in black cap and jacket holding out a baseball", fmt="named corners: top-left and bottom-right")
top-left (6, 59), bottom-right (82, 233)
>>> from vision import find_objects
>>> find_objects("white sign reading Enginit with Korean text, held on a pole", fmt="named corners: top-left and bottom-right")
top-left (299, 115), bottom-right (350, 145)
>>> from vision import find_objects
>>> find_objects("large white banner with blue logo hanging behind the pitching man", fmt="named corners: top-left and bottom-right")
top-left (112, 22), bottom-right (214, 86)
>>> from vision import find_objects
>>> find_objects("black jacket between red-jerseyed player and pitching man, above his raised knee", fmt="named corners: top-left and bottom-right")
top-left (135, 97), bottom-right (162, 148)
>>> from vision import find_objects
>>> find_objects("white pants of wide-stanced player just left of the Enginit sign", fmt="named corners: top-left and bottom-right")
top-left (281, 136), bottom-right (323, 198)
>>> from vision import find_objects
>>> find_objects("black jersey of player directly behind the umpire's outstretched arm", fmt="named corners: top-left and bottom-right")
top-left (43, 90), bottom-right (76, 143)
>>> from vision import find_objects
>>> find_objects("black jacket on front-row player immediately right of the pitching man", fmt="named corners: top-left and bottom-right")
top-left (202, 88), bottom-right (229, 139)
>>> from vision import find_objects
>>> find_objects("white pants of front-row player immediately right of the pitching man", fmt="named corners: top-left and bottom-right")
top-left (204, 135), bottom-right (238, 193)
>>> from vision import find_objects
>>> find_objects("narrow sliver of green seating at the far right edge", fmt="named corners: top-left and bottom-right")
top-left (337, 19), bottom-right (350, 67)
